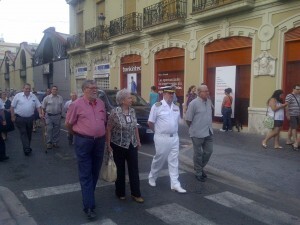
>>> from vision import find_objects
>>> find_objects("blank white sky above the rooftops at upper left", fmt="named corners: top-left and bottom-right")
top-left (0, 0), bottom-right (69, 44)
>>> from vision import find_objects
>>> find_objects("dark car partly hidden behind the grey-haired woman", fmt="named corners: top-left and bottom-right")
top-left (98, 90), bottom-right (153, 139)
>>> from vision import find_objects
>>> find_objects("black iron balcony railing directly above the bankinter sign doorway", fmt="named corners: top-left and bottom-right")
top-left (109, 12), bottom-right (142, 37)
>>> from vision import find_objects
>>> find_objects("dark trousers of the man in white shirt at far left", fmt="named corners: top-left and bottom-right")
top-left (15, 116), bottom-right (34, 151)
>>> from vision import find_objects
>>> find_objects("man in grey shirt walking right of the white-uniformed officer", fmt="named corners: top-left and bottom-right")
top-left (186, 85), bottom-right (213, 182)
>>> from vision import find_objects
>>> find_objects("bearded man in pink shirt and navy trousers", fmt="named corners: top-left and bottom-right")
top-left (65, 80), bottom-right (106, 219)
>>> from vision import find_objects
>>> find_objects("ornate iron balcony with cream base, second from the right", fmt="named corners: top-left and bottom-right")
top-left (143, 0), bottom-right (187, 34)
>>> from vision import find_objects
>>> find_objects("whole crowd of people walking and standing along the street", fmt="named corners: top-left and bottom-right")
top-left (0, 80), bottom-right (300, 219)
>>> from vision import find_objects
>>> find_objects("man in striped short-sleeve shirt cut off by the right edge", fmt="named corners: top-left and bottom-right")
top-left (285, 84), bottom-right (300, 150)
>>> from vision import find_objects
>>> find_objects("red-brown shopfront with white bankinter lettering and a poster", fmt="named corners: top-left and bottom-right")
top-left (120, 54), bottom-right (141, 95)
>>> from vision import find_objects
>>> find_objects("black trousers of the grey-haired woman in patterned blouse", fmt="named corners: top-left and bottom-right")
top-left (111, 143), bottom-right (141, 197)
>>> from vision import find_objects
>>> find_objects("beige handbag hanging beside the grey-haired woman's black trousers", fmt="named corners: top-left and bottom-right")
top-left (101, 152), bottom-right (117, 182)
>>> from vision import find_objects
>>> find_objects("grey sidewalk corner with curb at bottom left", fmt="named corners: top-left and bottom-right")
top-left (0, 186), bottom-right (37, 225)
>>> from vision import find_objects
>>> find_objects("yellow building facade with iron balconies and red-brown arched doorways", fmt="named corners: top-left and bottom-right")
top-left (66, 0), bottom-right (300, 133)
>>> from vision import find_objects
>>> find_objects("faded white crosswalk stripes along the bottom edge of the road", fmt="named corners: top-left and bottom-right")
top-left (75, 191), bottom-right (300, 225)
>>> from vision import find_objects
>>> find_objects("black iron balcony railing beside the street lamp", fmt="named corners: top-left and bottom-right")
top-left (85, 25), bottom-right (109, 45)
